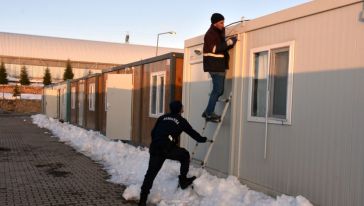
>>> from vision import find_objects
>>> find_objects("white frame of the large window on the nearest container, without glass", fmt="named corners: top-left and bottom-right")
top-left (248, 41), bottom-right (295, 125)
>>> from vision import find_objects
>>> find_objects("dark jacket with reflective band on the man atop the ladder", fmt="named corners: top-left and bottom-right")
top-left (203, 25), bottom-right (233, 72)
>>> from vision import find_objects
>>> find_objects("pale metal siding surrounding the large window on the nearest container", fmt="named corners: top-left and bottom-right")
top-left (239, 4), bottom-right (364, 206)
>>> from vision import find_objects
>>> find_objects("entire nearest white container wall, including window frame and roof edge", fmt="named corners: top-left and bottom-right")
top-left (183, 0), bottom-right (364, 206)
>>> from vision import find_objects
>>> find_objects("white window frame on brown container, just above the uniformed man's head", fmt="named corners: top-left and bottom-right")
top-left (149, 71), bottom-right (167, 118)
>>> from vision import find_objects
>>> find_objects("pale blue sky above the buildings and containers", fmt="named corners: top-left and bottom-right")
top-left (0, 0), bottom-right (309, 48)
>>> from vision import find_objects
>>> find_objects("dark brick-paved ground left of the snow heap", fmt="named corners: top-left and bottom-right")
top-left (0, 115), bottom-right (136, 206)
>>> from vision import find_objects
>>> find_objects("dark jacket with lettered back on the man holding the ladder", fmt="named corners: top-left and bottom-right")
top-left (150, 113), bottom-right (205, 153)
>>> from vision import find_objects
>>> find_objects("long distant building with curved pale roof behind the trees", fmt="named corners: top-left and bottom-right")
top-left (0, 32), bottom-right (183, 83)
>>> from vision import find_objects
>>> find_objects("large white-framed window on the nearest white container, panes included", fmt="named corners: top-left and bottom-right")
top-left (248, 41), bottom-right (293, 124)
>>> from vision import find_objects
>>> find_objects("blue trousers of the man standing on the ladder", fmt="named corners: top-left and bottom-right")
top-left (205, 72), bottom-right (225, 115)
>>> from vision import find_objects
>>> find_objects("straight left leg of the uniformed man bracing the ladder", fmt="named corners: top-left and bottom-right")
top-left (139, 154), bottom-right (165, 205)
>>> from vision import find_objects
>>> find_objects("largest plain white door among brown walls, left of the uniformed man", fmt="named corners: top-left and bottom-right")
top-left (106, 74), bottom-right (133, 140)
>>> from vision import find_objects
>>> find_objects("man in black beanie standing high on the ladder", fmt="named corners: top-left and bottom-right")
top-left (202, 13), bottom-right (237, 122)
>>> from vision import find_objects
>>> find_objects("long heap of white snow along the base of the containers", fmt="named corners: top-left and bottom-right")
top-left (32, 114), bottom-right (312, 206)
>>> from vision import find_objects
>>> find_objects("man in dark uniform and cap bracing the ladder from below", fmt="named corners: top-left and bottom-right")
top-left (139, 101), bottom-right (207, 206)
